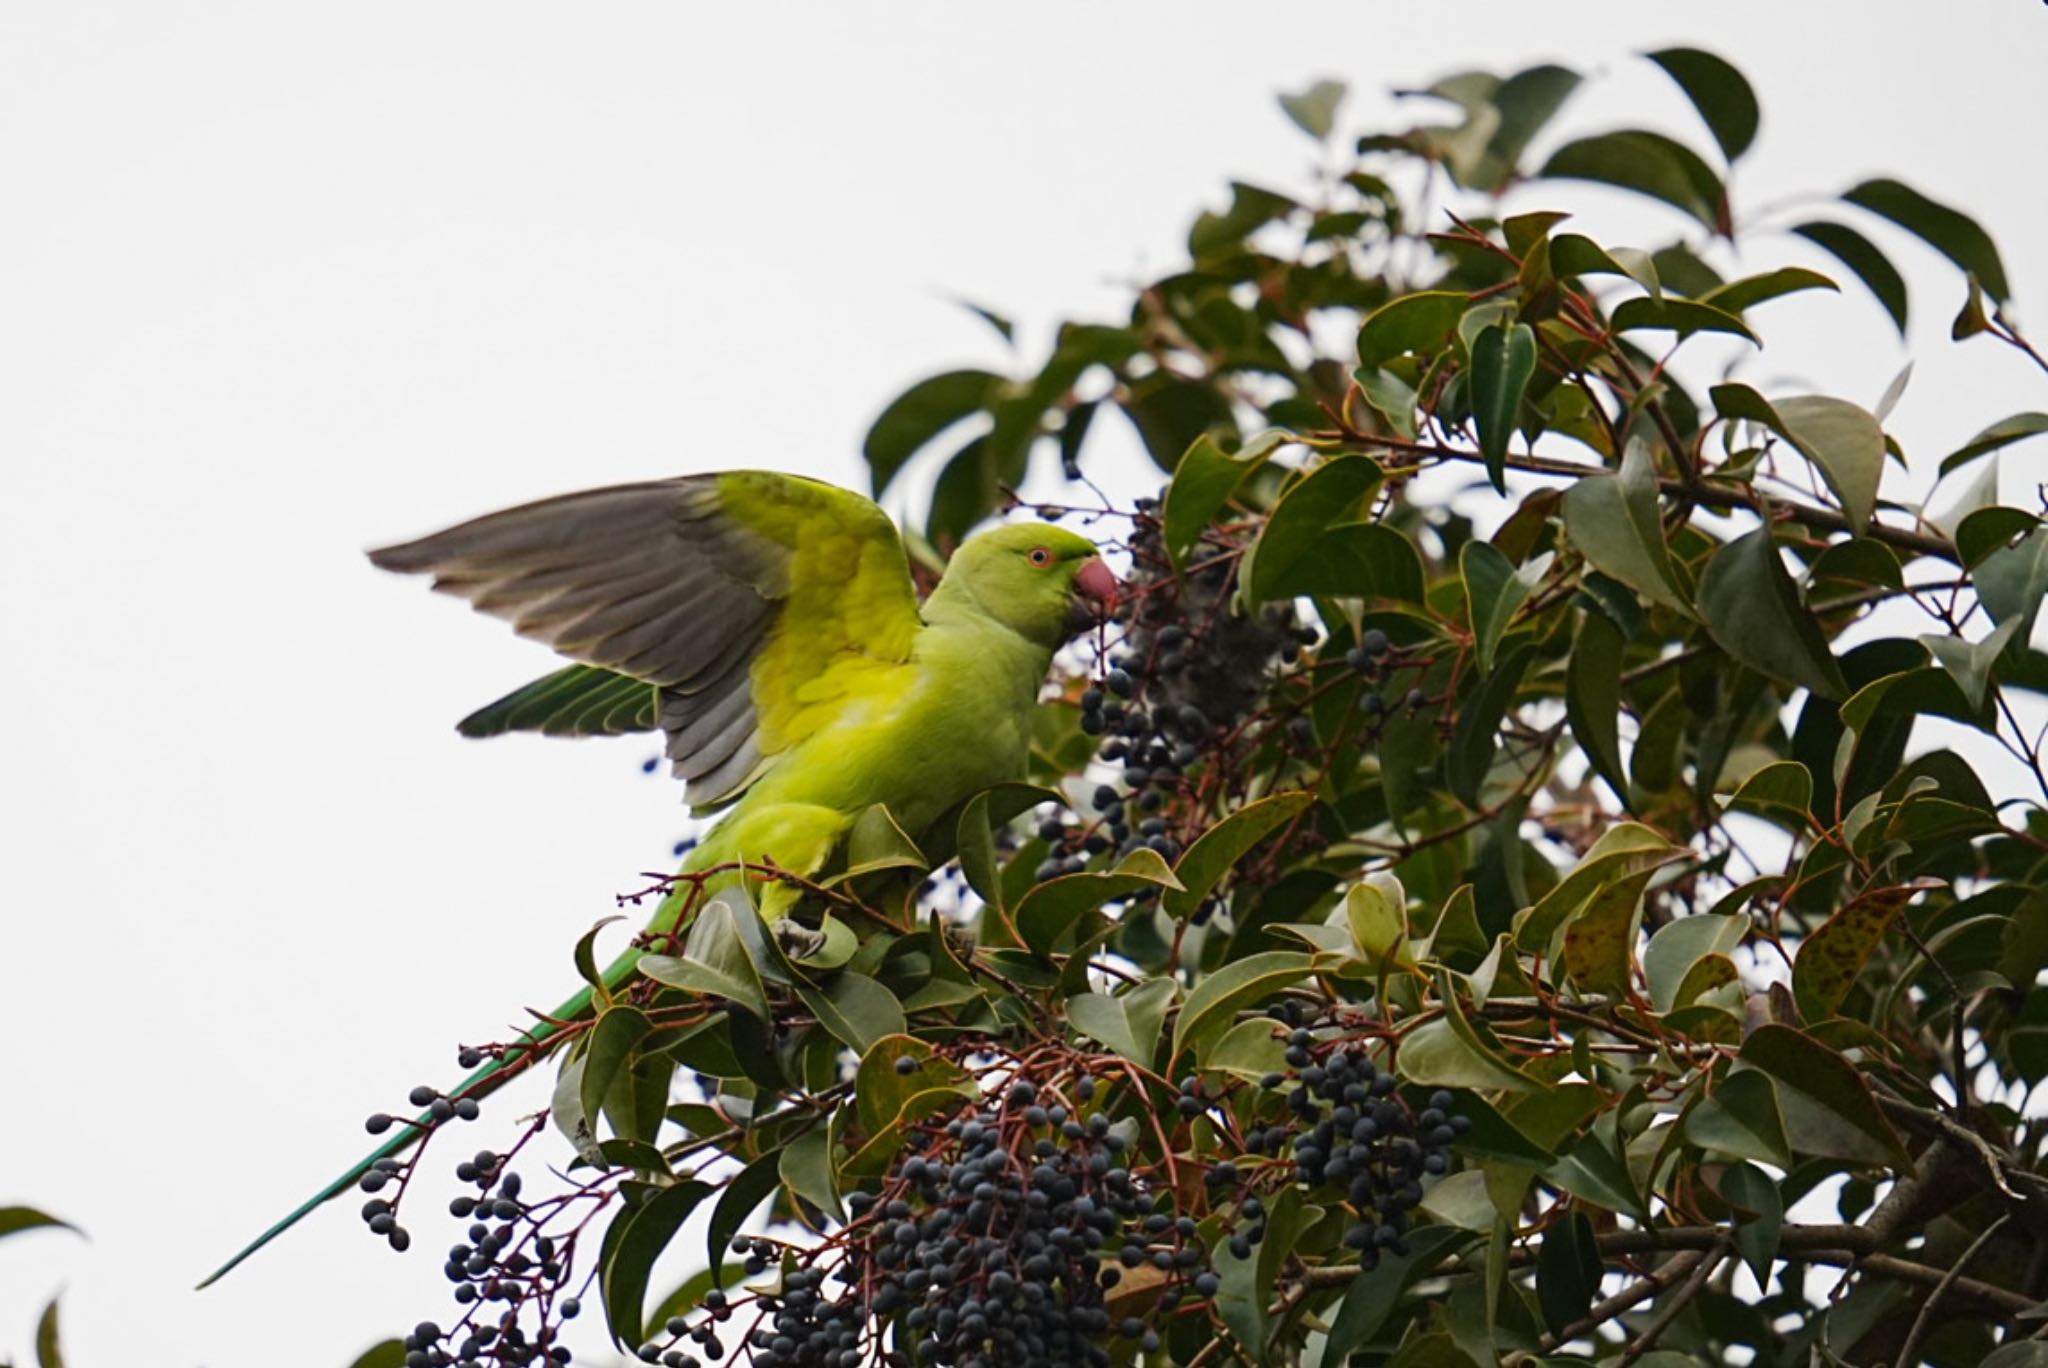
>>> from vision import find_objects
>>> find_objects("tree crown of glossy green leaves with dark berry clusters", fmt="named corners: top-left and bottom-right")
top-left (148, 49), bottom-right (2048, 1368)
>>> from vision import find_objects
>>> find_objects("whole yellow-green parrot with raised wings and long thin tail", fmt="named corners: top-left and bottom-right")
top-left (199, 471), bottom-right (1118, 1286)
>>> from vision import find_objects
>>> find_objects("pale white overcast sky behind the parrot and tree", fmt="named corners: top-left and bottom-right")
top-left (0, 0), bottom-right (2048, 1368)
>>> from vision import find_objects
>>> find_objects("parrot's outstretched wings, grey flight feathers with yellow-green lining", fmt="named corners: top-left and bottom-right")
top-left (371, 471), bottom-right (920, 807)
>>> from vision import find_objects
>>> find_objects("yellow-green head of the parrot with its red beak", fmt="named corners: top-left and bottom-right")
top-left (944, 522), bottom-right (1116, 647)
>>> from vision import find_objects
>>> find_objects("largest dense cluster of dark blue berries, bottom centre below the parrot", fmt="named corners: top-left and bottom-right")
top-left (641, 1061), bottom-right (1217, 1368)
